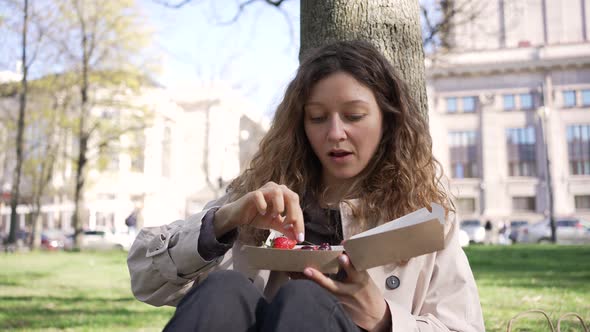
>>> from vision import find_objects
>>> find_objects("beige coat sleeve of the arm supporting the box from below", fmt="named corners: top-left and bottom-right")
top-left (387, 216), bottom-right (485, 332)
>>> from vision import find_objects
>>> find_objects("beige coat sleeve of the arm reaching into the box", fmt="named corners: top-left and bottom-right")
top-left (127, 197), bottom-right (227, 306)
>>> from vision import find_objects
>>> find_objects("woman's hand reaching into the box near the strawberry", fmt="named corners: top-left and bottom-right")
top-left (215, 182), bottom-right (305, 242)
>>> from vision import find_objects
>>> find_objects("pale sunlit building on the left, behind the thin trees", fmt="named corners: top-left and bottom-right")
top-left (0, 77), bottom-right (268, 234)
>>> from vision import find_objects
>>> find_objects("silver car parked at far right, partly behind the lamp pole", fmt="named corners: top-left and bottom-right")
top-left (517, 218), bottom-right (590, 244)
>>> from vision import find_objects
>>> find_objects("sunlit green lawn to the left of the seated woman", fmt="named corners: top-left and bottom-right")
top-left (0, 252), bottom-right (173, 331)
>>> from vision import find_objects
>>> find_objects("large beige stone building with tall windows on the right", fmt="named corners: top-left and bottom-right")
top-left (427, 0), bottom-right (590, 224)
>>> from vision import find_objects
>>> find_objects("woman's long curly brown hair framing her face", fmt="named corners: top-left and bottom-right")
top-left (228, 41), bottom-right (454, 243)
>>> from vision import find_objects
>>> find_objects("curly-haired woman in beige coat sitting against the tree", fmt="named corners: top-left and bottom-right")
top-left (128, 41), bottom-right (484, 331)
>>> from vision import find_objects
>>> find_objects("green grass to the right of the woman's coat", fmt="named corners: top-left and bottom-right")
top-left (465, 245), bottom-right (590, 332)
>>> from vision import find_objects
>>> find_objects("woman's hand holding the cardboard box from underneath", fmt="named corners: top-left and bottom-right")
top-left (303, 254), bottom-right (391, 331)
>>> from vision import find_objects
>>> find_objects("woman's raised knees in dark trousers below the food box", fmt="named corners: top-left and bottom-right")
top-left (164, 271), bottom-right (361, 332)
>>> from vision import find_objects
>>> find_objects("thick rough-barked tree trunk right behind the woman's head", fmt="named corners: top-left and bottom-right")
top-left (299, 0), bottom-right (428, 117)
